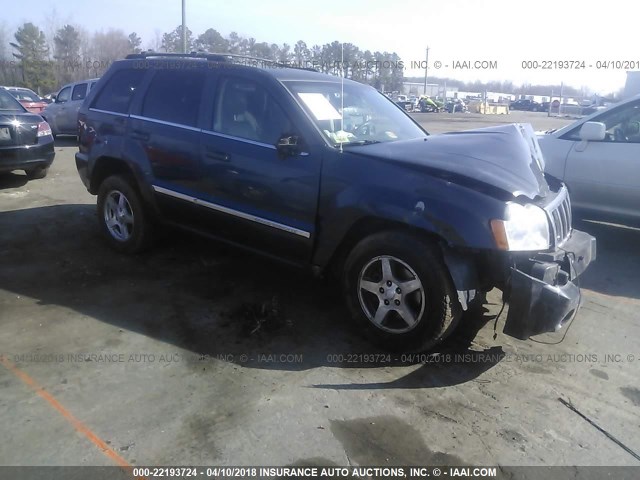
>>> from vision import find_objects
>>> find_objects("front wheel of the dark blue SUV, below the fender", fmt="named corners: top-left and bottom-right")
top-left (343, 232), bottom-right (462, 352)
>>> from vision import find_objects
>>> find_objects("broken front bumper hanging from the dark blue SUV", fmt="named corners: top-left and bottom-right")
top-left (503, 230), bottom-right (596, 340)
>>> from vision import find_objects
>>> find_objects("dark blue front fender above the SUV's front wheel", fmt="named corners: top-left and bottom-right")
top-left (314, 155), bottom-right (505, 267)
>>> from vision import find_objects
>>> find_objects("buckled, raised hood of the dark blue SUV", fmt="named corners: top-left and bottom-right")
top-left (351, 124), bottom-right (549, 200)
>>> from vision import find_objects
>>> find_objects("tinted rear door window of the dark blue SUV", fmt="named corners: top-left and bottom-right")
top-left (142, 70), bottom-right (206, 127)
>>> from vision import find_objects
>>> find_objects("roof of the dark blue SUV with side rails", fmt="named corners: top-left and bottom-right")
top-left (125, 52), bottom-right (357, 83)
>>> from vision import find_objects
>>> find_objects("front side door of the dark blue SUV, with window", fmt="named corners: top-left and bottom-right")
top-left (201, 70), bottom-right (321, 263)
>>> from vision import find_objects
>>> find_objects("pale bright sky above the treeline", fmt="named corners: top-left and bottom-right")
top-left (0, 0), bottom-right (640, 94)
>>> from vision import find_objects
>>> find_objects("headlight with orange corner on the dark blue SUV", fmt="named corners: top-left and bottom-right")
top-left (491, 203), bottom-right (550, 251)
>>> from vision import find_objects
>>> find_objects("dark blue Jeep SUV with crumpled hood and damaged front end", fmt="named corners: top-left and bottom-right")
top-left (76, 53), bottom-right (596, 351)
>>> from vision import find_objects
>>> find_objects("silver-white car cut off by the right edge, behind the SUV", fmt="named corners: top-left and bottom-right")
top-left (538, 95), bottom-right (640, 220)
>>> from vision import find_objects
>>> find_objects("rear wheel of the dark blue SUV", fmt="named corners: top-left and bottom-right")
top-left (98, 175), bottom-right (153, 253)
